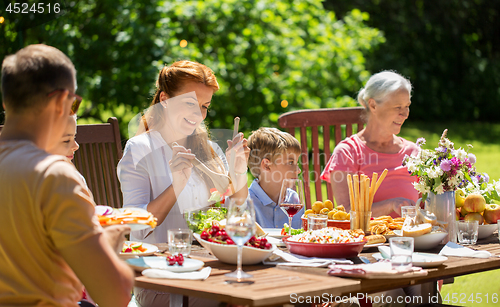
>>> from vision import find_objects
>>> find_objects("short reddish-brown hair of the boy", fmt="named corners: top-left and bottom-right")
top-left (248, 128), bottom-right (300, 178)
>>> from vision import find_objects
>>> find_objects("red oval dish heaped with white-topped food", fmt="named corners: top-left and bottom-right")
top-left (282, 227), bottom-right (367, 258)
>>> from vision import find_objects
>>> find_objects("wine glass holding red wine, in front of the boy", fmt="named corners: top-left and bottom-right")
top-left (278, 179), bottom-right (304, 235)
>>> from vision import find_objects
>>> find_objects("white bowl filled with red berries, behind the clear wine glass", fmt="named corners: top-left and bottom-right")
top-left (193, 225), bottom-right (276, 265)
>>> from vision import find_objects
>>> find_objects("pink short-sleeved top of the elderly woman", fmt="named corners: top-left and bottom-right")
top-left (321, 134), bottom-right (419, 202)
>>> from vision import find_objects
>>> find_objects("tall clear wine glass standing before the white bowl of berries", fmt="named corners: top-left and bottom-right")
top-left (226, 198), bottom-right (255, 282)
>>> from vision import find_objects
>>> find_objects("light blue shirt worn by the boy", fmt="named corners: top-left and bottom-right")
top-left (248, 179), bottom-right (304, 229)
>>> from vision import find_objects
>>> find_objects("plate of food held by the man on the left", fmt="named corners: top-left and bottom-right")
top-left (96, 206), bottom-right (156, 231)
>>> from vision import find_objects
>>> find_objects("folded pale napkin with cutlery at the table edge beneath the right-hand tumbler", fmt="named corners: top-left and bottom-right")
top-left (328, 261), bottom-right (427, 279)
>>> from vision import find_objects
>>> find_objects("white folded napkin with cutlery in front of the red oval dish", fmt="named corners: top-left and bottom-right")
top-left (263, 249), bottom-right (352, 268)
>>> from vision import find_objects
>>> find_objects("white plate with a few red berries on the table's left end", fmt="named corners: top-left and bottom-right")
top-left (125, 256), bottom-right (204, 272)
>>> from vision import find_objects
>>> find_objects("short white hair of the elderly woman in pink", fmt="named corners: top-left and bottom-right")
top-left (358, 70), bottom-right (411, 113)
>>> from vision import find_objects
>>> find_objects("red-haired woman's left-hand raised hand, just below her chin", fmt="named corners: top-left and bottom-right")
top-left (168, 144), bottom-right (195, 196)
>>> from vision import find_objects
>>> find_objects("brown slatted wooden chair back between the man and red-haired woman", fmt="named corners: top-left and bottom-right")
top-left (74, 117), bottom-right (123, 208)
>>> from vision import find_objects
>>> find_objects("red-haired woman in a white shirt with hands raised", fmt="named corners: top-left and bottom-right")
top-left (118, 61), bottom-right (250, 307)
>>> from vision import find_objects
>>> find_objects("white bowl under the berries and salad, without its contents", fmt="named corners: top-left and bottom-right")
top-left (193, 233), bottom-right (276, 265)
